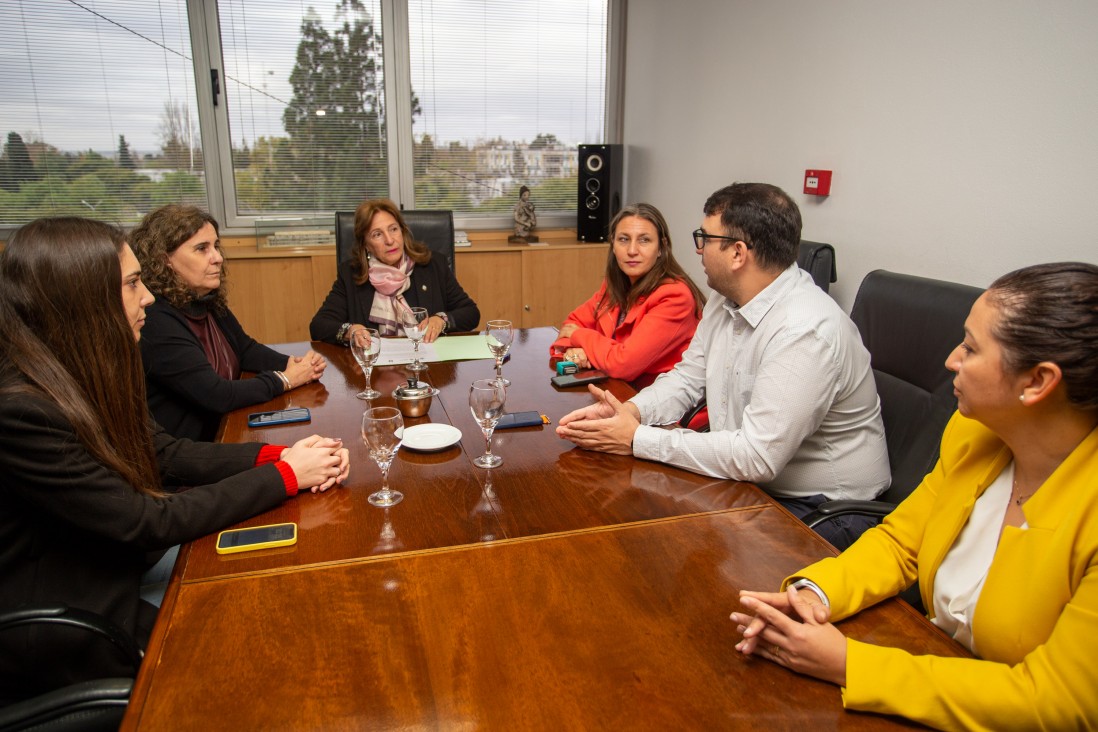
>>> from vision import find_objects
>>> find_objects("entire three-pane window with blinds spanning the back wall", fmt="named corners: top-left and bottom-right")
top-left (0, 0), bottom-right (615, 228)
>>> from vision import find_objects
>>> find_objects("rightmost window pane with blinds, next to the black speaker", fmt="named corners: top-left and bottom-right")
top-left (408, 0), bottom-right (607, 217)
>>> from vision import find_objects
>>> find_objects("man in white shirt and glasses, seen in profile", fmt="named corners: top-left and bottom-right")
top-left (557, 183), bottom-right (889, 548)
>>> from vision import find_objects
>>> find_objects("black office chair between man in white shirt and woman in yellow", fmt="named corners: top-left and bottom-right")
top-left (804, 270), bottom-right (984, 527)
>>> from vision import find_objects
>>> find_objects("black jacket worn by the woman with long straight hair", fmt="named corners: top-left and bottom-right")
top-left (0, 393), bottom-right (287, 699)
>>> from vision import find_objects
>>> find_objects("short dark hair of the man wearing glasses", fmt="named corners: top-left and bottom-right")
top-left (703, 183), bottom-right (800, 271)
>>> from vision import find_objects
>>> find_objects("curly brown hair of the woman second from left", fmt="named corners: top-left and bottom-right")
top-left (130, 203), bottom-right (228, 314)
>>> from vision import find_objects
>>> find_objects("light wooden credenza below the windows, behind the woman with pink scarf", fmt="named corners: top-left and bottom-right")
top-left (223, 229), bottom-right (608, 344)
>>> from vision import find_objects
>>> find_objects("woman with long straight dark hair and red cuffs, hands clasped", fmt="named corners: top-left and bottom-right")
top-left (0, 217), bottom-right (348, 699)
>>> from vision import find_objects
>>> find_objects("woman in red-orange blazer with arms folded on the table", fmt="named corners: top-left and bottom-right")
top-left (550, 203), bottom-right (705, 388)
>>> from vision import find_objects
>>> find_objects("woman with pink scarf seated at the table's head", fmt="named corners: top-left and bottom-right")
top-left (309, 199), bottom-right (480, 346)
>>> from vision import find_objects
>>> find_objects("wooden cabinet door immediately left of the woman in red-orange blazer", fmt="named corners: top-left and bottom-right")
top-left (522, 244), bottom-right (607, 328)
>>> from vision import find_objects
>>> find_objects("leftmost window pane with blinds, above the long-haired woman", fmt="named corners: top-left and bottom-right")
top-left (0, 0), bottom-right (208, 226)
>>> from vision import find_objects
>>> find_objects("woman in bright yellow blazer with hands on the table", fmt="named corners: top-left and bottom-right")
top-left (731, 263), bottom-right (1098, 730)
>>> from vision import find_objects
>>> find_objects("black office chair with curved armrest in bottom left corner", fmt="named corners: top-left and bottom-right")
top-left (0, 606), bottom-right (143, 732)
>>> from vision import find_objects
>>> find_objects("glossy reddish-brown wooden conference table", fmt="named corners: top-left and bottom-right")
top-left (123, 328), bottom-right (965, 731)
